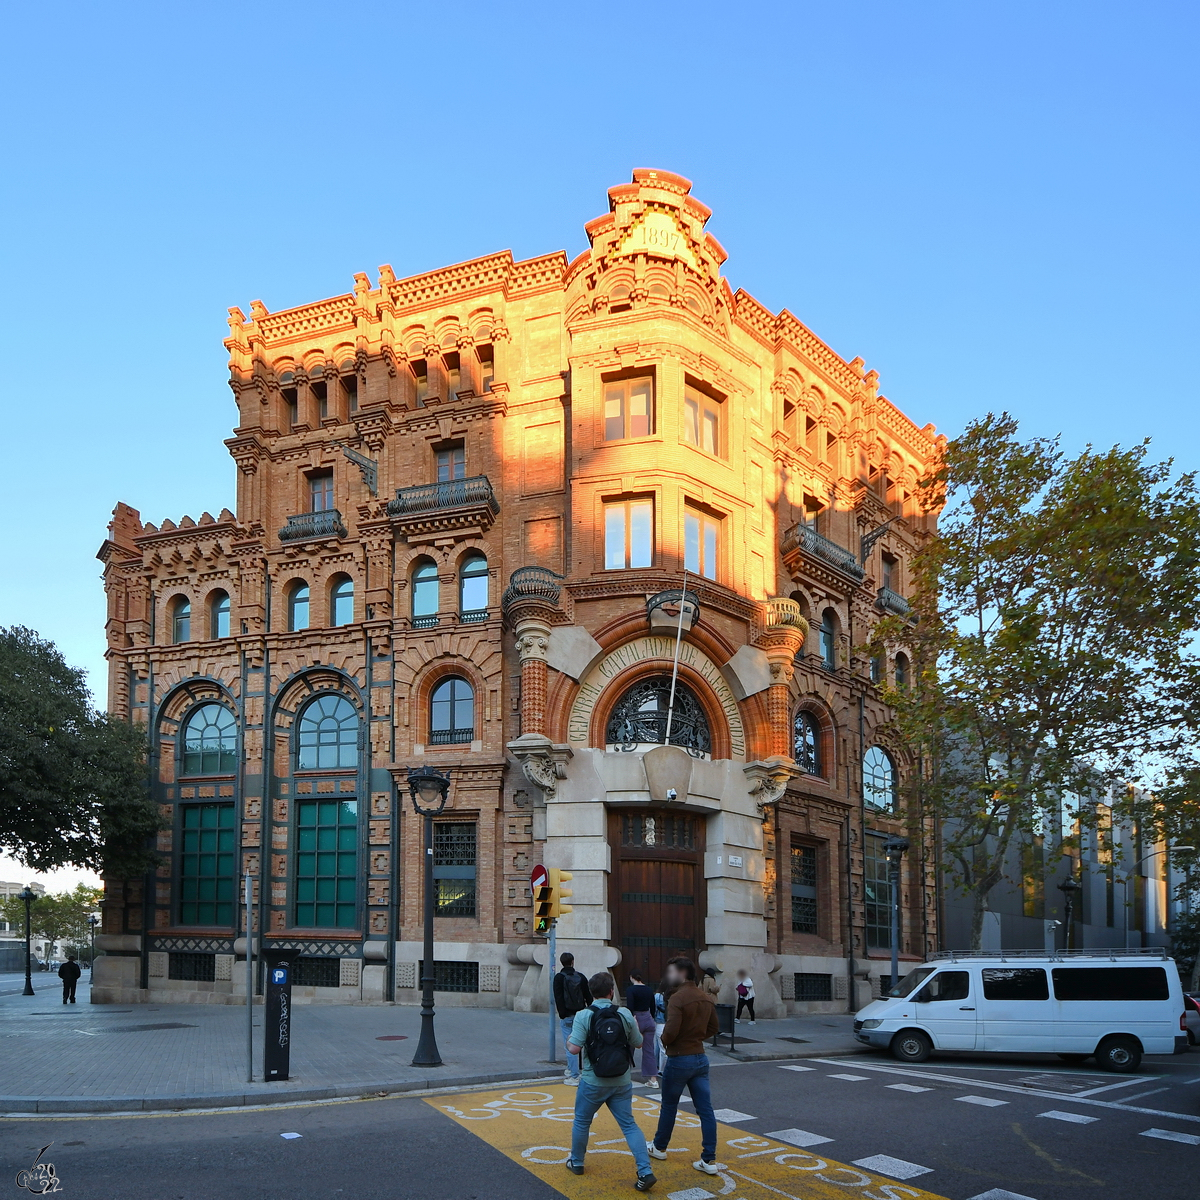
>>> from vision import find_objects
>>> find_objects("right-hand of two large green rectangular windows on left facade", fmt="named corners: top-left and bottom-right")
top-left (295, 800), bottom-right (359, 929)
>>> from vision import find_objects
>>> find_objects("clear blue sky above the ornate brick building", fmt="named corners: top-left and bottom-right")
top-left (0, 0), bottom-right (1200, 696)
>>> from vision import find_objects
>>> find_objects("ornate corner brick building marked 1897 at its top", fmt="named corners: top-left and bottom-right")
top-left (94, 170), bottom-right (937, 1016)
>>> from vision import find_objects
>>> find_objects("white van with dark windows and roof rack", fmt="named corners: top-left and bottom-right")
top-left (854, 949), bottom-right (1187, 1072)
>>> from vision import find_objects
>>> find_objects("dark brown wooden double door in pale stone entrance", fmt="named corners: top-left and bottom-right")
top-left (608, 809), bottom-right (707, 990)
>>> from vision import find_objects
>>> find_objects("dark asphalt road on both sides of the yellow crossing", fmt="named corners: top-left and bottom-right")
top-left (0, 1051), bottom-right (1200, 1200)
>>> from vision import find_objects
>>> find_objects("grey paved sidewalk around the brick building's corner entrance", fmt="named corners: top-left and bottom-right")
top-left (0, 972), bottom-right (859, 1115)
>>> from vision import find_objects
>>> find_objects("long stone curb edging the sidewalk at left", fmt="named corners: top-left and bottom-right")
top-left (0, 1068), bottom-right (563, 1117)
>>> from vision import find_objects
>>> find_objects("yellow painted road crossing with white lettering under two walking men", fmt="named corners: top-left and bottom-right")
top-left (425, 1084), bottom-right (943, 1200)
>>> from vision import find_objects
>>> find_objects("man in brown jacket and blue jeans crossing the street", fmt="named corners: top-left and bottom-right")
top-left (649, 958), bottom-right (718, 1175)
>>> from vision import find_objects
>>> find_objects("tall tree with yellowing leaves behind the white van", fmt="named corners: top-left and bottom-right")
top-left (871, 414), bottom-right (1200, 948)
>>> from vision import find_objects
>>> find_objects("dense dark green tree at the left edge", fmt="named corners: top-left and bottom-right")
top-left (0, 626), bottom-right (158, 875)
